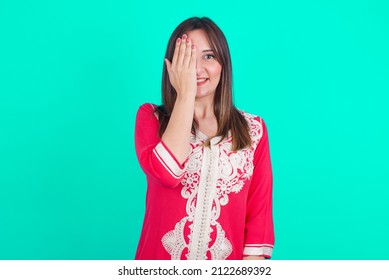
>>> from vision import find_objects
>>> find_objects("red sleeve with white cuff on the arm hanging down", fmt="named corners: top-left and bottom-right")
top-left (243, 119), bottom-right (274, 258)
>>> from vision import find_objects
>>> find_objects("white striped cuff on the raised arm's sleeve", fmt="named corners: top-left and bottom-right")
top-left (153, 141), bottom-right (185, 179)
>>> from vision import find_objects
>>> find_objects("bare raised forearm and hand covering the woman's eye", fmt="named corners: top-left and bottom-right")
top-left (162, 34), bottom-right (197, 164)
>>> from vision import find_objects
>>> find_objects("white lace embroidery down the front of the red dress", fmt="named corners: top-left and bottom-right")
top-left (162, 112), bottom-right (262, 260)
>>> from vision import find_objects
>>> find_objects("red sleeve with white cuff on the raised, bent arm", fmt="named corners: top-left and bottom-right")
top-left (135, 104), bottom-right (186, 187)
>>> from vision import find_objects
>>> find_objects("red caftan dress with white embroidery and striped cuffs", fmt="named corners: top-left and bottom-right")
top-left (135, 104), bottom-right (274, 260)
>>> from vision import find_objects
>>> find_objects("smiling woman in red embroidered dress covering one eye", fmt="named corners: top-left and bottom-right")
top-left (135, 17), bottom-right (274, 259)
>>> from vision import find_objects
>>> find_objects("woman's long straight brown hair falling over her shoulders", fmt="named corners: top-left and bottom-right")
top-left (156, 17), bottom-right (251, 151)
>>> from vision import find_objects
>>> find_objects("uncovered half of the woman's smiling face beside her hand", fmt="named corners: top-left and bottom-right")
top-left (187, 29), bottom-right (222, 99)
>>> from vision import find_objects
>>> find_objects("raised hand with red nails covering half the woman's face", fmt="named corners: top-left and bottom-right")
top-left (165, 34), bottom-right (197, 98)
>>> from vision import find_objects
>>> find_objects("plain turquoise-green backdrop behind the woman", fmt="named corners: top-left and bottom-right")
top-left (0, 0), bottom-right (389, 259)
